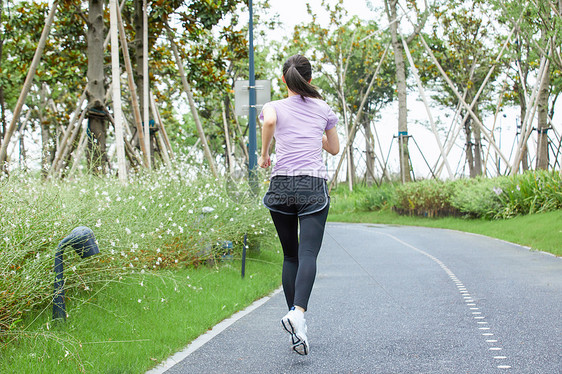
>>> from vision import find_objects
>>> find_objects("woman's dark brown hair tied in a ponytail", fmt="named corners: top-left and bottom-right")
top-left (283, 55), bottom-right (322, 100)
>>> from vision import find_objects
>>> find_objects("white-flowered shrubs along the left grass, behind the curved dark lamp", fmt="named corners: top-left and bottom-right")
top-left (0, 165), bottom-right (273, 332)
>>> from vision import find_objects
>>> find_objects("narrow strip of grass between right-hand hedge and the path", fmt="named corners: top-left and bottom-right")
top-left (328, 207), bottom-right (562, 256)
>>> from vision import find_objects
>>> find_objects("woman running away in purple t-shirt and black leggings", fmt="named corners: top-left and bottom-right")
top-left (258, 55), bottom-right (340, 355)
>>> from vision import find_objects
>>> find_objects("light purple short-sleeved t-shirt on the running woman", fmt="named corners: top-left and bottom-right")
top-left (260, 95), bottom-right (338, 179)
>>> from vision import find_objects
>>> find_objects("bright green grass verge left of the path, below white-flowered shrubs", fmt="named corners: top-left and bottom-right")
top-left (0, 244), bottom-right (281, 374)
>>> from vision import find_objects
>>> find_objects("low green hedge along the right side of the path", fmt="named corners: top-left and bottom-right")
top-left (333, 170), bottom-right (562, 219)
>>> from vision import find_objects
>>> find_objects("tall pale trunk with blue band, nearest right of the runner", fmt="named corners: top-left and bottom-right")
top-left (385, 0), bottom-right (411, 183)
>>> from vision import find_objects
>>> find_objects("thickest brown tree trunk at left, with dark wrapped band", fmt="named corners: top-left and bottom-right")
top-left (86, 0), bottom-right (108, 174)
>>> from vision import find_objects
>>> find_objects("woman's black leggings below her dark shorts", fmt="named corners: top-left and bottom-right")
top-left (270, 204), bottom-right (330, 310)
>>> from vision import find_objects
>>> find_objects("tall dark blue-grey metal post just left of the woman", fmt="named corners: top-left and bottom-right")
top-left (248, 0), bottom-right (257, 190)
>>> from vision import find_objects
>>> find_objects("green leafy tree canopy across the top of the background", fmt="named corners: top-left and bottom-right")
top-left (0, 0), bottom-right (562, 178)
